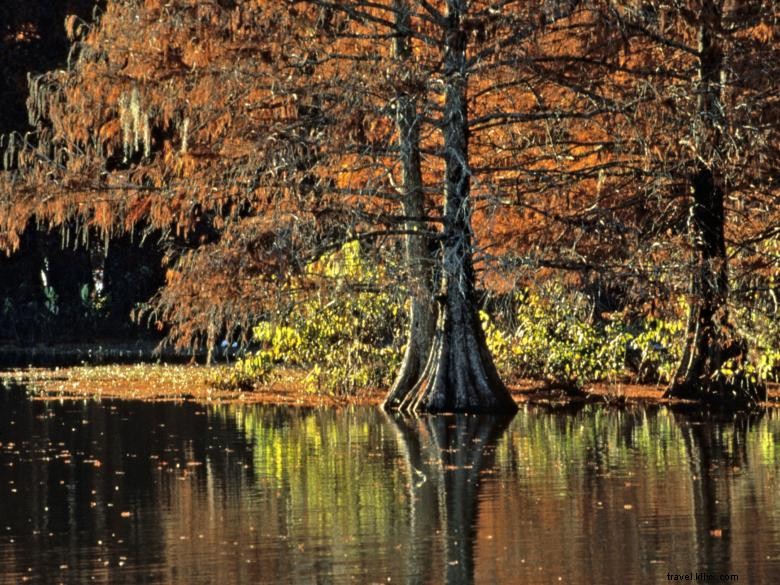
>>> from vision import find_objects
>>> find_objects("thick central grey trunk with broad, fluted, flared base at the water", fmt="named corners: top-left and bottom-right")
top-left (400, 0), bottom-right (517, 413)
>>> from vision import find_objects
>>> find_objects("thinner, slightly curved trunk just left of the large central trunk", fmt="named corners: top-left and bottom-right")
top-left (384, 0), bottom-right (437, 409)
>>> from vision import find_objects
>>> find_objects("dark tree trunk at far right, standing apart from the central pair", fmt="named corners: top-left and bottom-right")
top-left (666, 0), bottom-right (763, 405)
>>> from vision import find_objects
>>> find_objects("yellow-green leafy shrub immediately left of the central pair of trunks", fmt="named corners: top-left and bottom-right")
top-left (210, 242), bottom-right (405, 395)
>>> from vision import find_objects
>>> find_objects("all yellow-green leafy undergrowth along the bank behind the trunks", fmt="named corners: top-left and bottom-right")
top-left (211, 243), bottom-right (780, 396)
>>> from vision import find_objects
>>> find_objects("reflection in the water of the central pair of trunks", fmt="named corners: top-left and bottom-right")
top-left (388, 415), bottom-right (511, 583)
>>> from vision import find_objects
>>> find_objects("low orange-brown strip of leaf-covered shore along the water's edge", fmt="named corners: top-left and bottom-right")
top-left (0, 363), bottom-right (780, 408)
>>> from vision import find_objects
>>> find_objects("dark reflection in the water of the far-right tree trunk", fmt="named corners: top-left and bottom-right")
top-left (674, 410), bottom-right (763, 574)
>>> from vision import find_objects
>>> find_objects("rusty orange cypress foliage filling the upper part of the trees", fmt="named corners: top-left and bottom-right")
top-left (0, 0), bottom-right (780, 342)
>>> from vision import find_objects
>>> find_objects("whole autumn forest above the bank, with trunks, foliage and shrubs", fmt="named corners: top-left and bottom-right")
top-left (0, 0), bottom-right (780, 410)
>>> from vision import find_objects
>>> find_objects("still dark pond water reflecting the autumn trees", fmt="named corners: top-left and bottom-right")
top-left (0, 390), bottom-right (780, 585)
